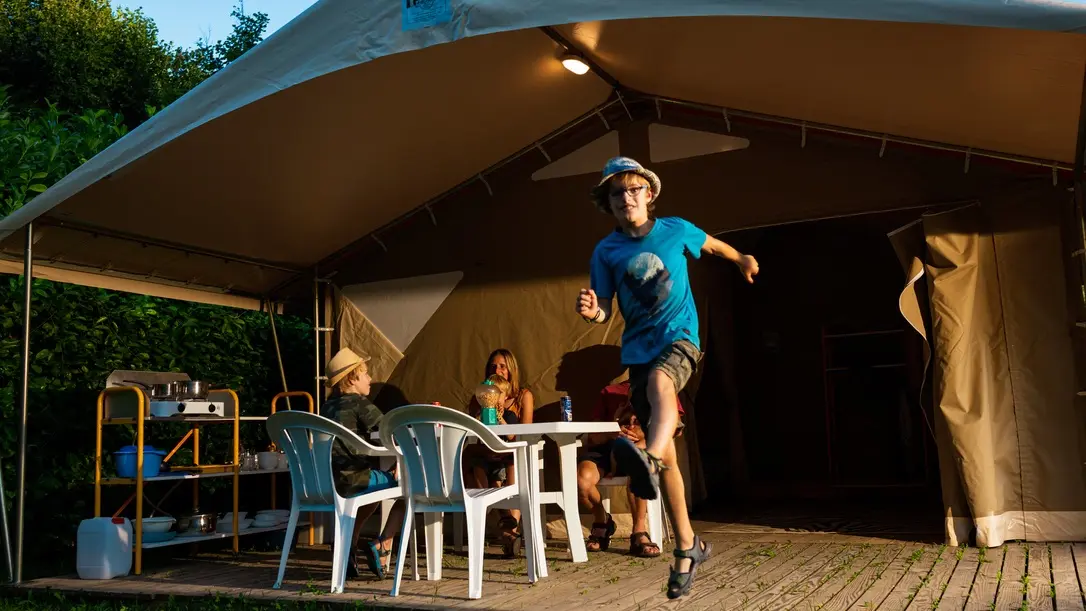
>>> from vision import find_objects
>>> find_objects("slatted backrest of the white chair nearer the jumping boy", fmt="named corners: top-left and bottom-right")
top-left (379, 405), bottom-right (513, 504)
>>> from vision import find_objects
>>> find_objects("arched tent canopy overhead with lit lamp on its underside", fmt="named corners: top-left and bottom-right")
top-left (0, 0), bottom-right (1086, 303)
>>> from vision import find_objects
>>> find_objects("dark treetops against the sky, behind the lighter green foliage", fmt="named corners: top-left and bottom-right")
top-left (0, 0), bottom-right (268, 127)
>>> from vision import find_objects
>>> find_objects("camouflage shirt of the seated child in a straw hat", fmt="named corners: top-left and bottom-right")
top-left (320, 392), bottom-right (383, 496)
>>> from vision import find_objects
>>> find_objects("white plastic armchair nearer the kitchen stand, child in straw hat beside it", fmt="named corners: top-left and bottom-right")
top-left (266, 410), bottom-right (418, 594)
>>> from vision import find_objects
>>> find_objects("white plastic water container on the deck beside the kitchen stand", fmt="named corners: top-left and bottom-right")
top-left (75, 518), bottom-right (136, 580)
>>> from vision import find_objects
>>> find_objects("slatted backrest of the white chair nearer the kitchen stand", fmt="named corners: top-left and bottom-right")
top-left (266, 410), bottom-right (391, 506)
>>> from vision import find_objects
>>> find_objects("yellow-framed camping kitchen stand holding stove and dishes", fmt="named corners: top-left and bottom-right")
top-left (94, 386), bottom-right (314, 575)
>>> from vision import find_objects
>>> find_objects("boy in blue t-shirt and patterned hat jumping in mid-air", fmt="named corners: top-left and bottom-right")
top-left (577, 157), bottom-right (758, 598)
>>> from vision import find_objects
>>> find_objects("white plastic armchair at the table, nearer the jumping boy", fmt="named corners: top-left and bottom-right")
top-left (379, 405), bottom-right (538, 598)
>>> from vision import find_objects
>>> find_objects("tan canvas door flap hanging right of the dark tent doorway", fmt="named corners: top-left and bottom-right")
top-left (889, 202), bottom-right (1086, 546)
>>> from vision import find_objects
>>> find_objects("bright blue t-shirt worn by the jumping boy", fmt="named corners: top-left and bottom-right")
top-left (591, 217), bottom-right (706, 366)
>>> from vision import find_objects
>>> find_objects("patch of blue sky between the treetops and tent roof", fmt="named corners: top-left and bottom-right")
top-left (113, 0), bottom-right (315, 47)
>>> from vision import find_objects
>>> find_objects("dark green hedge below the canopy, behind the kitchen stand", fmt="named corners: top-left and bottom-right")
top-left (0, 277), bottom-right (313, 578)
